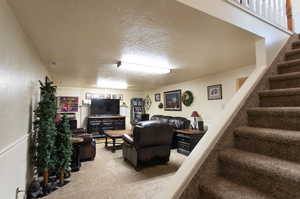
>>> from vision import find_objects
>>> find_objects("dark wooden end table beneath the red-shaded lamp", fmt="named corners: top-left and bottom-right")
top-left (176, 129), bottom-right (205, 155)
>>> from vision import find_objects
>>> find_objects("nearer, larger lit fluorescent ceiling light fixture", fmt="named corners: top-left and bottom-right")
top-left (117, 61), bottom-right (171, 74)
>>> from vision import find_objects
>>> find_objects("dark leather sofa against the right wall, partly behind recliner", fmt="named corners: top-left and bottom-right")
top-left (151, 115), bottom-right (191, 148)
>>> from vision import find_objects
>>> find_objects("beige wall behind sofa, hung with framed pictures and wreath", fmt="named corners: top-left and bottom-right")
top-left (147, 66), bottom-right (255, 126)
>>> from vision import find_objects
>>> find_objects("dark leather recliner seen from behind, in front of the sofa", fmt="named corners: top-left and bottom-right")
top-left (123, 121), bottom-right (174, 169)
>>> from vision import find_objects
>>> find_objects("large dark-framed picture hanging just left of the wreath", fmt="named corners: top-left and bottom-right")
top-left (164, 90), bottom-right (181, 111)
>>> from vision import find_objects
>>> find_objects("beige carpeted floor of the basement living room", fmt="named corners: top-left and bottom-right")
top-left (45, 144), bottom-right (186, 199)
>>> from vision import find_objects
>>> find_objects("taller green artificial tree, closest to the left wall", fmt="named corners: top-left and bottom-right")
top-left (34, 77), bottom-right (57, 186)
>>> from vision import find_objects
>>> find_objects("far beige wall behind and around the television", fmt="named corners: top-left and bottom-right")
top-left (57, 87), bottom-right (144, 128)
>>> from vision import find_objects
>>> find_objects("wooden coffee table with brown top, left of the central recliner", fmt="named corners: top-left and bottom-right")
top-left (104, 129), bottom-right (132, 153)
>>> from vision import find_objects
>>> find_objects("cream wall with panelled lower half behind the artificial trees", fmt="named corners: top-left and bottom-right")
top-left (0, 0), bottom-right (47, 199)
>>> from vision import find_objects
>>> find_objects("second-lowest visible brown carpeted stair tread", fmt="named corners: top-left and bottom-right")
top-left (219, 149), bottom-right (300, 184)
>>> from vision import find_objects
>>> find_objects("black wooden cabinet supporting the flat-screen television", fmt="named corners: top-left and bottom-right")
top-left (87, 116), bottom-right (126, 138)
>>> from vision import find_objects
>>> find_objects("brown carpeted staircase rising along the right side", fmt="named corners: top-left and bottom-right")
top-left (199, 36), bottom-right (300, 199)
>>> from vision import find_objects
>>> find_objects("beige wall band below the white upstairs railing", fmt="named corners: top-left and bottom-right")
top-left (177, 0), bottom-right (290, 67)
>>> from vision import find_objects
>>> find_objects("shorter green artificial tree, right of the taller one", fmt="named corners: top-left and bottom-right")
top-left (55, 114), bottom-right (72, 185)
